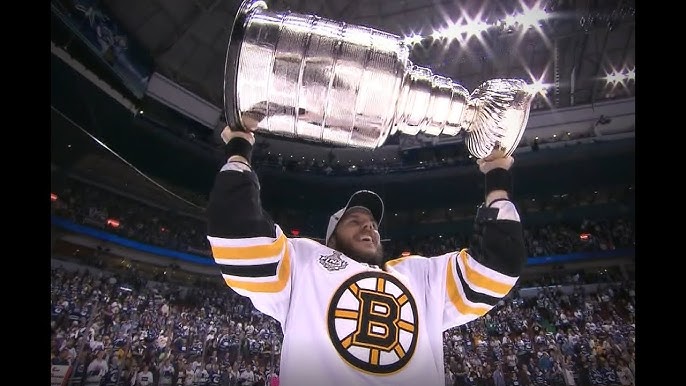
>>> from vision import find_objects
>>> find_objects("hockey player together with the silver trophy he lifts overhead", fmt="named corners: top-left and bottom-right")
top-left (208, 0), bottom-right (532, 386)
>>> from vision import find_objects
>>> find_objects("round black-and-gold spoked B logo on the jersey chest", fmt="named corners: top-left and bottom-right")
top-left (328, 272), bottom-right (419, 374)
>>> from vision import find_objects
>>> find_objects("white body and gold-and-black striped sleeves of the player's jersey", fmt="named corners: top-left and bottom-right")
top-left (208, 201), bottom-right (519, 386)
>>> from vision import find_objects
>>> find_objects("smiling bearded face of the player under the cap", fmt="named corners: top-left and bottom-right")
top-left (329, 207), bottom-right (383, 265)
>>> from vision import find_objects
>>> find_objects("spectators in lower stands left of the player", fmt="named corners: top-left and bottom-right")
top-left (51, 267), bottom-right (281, 386)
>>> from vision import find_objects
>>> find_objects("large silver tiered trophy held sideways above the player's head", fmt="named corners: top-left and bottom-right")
top-left (224, 0), bottom-right (534, 158)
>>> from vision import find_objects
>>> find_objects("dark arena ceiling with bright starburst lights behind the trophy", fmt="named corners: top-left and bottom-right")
top-left (101, 0), bottom-right (635, 108)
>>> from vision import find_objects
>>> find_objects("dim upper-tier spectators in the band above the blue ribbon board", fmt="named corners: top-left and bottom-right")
top-left (52, 179), bottom-right (634, 257)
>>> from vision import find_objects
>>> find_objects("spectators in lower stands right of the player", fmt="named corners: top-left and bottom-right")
top-left (444, 281), bottom-right (635, 386)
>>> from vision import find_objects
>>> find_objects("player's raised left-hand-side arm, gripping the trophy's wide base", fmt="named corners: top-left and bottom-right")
top-left (207, 128), bottom-right (292, 324)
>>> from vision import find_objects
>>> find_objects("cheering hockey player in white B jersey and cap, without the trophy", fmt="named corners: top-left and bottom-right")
top-left (208, 128), bottom-right (526, 386)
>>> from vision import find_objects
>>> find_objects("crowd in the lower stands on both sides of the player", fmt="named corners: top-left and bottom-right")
top-left (51, 255), bottom-right (635, 386)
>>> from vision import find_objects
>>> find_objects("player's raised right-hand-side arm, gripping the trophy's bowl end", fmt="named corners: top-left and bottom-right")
top-left (388, 152), bottom-right (526, 329)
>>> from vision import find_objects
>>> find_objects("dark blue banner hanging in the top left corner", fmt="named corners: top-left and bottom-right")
top-left (51, 0), bottom-right (153, 98)
